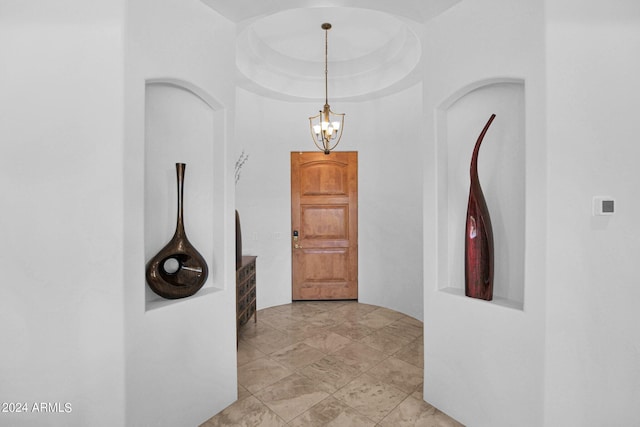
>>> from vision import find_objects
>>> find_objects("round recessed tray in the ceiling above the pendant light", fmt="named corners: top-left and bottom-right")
top-left (236, 8), bottom-right (421, 101)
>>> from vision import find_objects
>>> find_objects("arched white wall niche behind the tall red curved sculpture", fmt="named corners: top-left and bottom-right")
top-left (436, 78), bottom-right (526, 310)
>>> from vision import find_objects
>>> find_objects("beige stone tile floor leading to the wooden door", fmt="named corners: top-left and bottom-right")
top-left (201, 301), bottom-right (462, 427)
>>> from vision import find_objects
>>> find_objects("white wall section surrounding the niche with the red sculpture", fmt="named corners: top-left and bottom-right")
top-left (423, 0), bottom-right (546, 427)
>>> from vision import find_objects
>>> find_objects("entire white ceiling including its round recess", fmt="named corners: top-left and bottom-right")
top-left (202, 0), bottom-right (461, 101)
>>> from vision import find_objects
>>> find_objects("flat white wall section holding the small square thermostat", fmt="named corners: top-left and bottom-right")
top-left (545, 0), bottom-right (640, 426)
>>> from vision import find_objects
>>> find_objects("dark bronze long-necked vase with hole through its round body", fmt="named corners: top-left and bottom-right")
top-left (146, 163), bottom-right (209, 299)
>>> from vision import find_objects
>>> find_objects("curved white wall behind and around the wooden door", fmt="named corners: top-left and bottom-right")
top-left (236, 86), bottom-right (422, 319)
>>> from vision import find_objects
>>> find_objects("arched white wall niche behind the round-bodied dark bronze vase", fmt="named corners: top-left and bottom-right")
top-left (144, 78), bottom-right (225, 311)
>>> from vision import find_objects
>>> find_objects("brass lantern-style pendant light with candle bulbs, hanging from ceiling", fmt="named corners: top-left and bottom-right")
top-left (309, 22), bottom-right (344, 154)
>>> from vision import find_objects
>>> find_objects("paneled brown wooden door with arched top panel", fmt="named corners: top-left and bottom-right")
top-left (291, 151), bottom-right (358, 301)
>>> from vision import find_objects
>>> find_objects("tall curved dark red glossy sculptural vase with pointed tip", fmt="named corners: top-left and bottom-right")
top-left (464, 114), bottom-right (496, 301)
